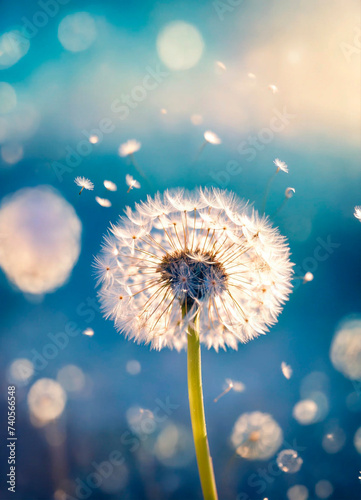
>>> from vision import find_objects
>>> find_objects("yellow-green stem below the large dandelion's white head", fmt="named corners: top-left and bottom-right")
top-left (183, 308), bottom-right (218, 500)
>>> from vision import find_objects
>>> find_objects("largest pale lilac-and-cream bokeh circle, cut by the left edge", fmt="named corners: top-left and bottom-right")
top-left (0, 186), bottom-right (81, 294)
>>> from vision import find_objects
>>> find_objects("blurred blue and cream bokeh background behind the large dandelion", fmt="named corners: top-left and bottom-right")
top-left (0, 0), bottom-right (361, 500)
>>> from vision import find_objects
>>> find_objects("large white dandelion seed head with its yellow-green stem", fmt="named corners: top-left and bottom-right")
top-left (95, 189), bottom-right (293, 499)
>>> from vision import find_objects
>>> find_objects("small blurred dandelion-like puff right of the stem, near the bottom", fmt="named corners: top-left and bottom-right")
top-left (231, 411), bottom-right (283, 460)
